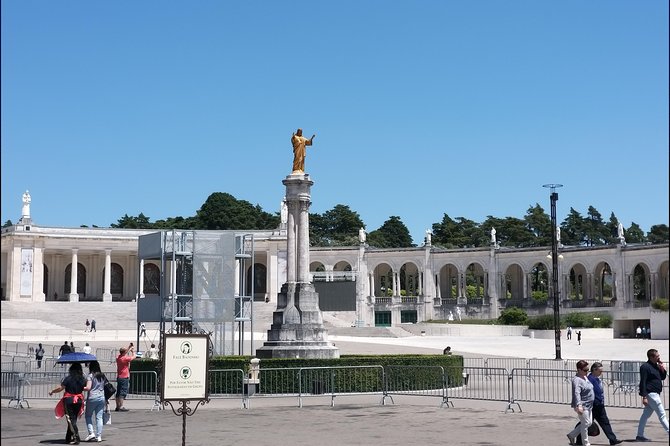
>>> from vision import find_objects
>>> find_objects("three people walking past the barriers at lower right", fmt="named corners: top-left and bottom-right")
top-left (567, 349), bottom-right (670, 446)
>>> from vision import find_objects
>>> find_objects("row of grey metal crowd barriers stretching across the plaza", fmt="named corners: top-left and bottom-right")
top-left (0, 358), bottom-right (669, 411)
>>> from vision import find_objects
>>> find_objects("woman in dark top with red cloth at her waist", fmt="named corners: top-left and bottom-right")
top-left (49, 363), bottom-right (86, 444)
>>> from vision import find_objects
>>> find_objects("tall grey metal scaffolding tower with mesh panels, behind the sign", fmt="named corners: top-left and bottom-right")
top-left (138, 230), bottom-right (254, 355)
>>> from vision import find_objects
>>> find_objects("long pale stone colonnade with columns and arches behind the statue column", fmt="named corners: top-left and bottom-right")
top-left (0, 216), bottom-right (670, 339)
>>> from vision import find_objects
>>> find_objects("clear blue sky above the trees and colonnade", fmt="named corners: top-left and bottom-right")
top-left (1, 0), bottom-right (669, 243)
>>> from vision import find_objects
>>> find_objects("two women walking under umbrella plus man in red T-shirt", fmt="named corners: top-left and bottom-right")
top-left (50, 342), bottom-right (137, 444)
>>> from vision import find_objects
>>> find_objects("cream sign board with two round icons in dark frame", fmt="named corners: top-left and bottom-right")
top-left (161, 334), bottom-right (209, 401)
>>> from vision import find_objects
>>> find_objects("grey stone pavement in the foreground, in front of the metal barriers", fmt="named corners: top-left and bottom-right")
top-left (1, 395), bottom-right (668, 446)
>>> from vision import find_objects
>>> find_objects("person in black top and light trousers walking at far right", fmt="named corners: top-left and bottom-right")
top-left (635, 348), bottom-right (670, 441)
